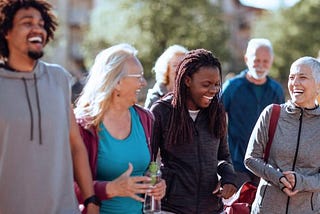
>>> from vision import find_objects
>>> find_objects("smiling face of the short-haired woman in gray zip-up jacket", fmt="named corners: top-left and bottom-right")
top-left (288, 64), bottom-right (319, 108)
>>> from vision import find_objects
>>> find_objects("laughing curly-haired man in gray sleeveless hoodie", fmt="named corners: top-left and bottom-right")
top-left (0, 0), bottom-right (99, 214)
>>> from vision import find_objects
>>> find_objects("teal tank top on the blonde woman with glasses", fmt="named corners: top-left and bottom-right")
top-left (97, 107), bottom-right (150, 214)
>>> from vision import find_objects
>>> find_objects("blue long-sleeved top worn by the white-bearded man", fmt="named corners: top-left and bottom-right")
top-left (222, 70), bottom-right (285, 171)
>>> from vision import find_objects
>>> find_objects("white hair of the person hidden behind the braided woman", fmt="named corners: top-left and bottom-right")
top-left (153, 45), bottom-right (188, 83)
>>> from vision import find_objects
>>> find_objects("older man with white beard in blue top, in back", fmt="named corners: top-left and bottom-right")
top-left (222, 38), bottom-right (285, 187)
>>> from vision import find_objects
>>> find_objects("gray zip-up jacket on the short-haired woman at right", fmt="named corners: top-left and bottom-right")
top-left (244, 101), bottom-right (320, 214)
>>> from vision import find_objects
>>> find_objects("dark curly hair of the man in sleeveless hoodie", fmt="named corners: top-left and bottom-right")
top-left (0, 0), bottom-right (58, 58)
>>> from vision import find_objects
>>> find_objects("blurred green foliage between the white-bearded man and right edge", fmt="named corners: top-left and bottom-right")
top-left (254, 0), bottom-right (320, 85)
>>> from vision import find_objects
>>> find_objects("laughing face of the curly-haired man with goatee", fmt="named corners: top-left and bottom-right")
top-left (5, 7), bottom-right (47, 60)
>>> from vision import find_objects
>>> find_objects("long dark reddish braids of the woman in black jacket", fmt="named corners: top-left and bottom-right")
top-left (168, 49), bottom-right (226, 144)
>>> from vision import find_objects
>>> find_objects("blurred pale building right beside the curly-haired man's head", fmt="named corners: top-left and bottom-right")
top-left (47, 0), bottom-right (94, 78)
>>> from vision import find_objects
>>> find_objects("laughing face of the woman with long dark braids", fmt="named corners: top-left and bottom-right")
top-left (185, 67), bottom-right (221, 110)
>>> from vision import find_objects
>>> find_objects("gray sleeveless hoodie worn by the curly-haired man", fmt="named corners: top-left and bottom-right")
top-left (0, 61), bottom-right (79, 214)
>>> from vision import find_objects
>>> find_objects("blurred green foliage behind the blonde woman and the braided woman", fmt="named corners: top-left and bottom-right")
top-left (84, 0), bottom-right (229, 77)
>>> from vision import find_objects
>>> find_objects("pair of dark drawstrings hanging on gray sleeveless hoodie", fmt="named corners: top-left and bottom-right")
top-left (22, 74), bottom-right (42, 145)
